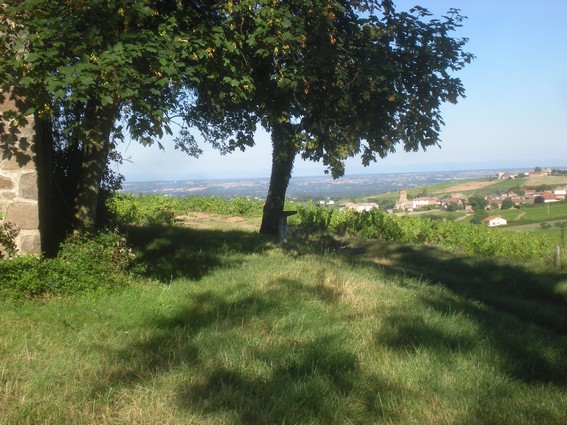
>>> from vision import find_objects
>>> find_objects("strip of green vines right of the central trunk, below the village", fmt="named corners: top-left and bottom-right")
top-left (297, 206), bottom-right (552, 260)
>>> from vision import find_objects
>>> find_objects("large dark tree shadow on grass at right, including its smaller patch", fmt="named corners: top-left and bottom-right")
top-left (347, 238), bottom-right (567, 386)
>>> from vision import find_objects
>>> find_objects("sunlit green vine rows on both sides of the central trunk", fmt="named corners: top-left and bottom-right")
top-left (109, 195), bottom-right (559, 261)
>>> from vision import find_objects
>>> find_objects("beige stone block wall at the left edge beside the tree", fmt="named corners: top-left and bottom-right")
top-left (0, 88), bottom-right (41, 254)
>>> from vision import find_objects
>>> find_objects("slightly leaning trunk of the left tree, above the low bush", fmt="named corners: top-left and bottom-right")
top-left (73, 102), bottom-right (118, 231)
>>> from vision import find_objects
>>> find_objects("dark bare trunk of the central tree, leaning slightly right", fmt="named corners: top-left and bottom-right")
top-left (260, 123), bottom-right (297, 236)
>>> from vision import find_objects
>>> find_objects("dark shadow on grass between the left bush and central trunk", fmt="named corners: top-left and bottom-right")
top-left (126, 226), bottom-right (273, 283)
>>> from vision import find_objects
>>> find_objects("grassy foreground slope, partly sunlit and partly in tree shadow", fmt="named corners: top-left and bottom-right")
top-left (0, 217), bottom-right (567, 424)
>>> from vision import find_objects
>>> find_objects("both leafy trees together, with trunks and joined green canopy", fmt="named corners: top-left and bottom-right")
top-left (0, 0), bottom-right (473, 255)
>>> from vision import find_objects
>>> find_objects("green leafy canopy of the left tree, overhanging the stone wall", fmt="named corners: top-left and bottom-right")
top-left (0, 0), bottom-right (204, 144)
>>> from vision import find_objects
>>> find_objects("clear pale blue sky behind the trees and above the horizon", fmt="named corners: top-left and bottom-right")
top-left (116, 0), bottom-right (567, 182)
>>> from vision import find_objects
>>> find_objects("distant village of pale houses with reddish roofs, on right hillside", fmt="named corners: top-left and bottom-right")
top-left (319, 168), bottom-right (567, 227)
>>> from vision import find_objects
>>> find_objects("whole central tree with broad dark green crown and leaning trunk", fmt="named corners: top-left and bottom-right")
top-left (183, 0), bottom-right (473, 235)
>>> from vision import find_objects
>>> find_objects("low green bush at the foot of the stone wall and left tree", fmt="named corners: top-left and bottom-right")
top-left (0, 231), bottom-right (134, 298)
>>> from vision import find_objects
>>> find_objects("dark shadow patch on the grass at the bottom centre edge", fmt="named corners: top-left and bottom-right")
top-left (179, 334), bottom-right (357, 424)
